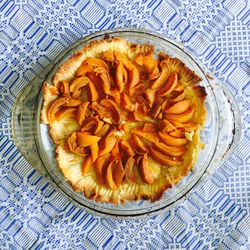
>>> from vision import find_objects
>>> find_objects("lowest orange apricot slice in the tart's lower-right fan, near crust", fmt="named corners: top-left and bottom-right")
top-left (149, 148), bottom-right (182, 167)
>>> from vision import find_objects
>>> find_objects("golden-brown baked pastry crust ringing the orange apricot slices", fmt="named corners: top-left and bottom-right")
top-left (41, 37), bottom-right (206, 204)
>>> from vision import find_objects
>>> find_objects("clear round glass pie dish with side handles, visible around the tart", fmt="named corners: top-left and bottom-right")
top-left (12, 29), bottom-right (240, 218)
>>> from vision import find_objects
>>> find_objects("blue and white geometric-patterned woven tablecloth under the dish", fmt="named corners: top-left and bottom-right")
top-left (0, 0), bottom-right (250, 249)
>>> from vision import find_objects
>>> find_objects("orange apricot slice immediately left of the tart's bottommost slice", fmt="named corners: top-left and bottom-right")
top-left (94, 154), bottom-right (112, 184)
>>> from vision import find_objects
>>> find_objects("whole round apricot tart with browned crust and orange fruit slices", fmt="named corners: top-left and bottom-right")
top-left (42, 37), bottom-right (206, 204)
